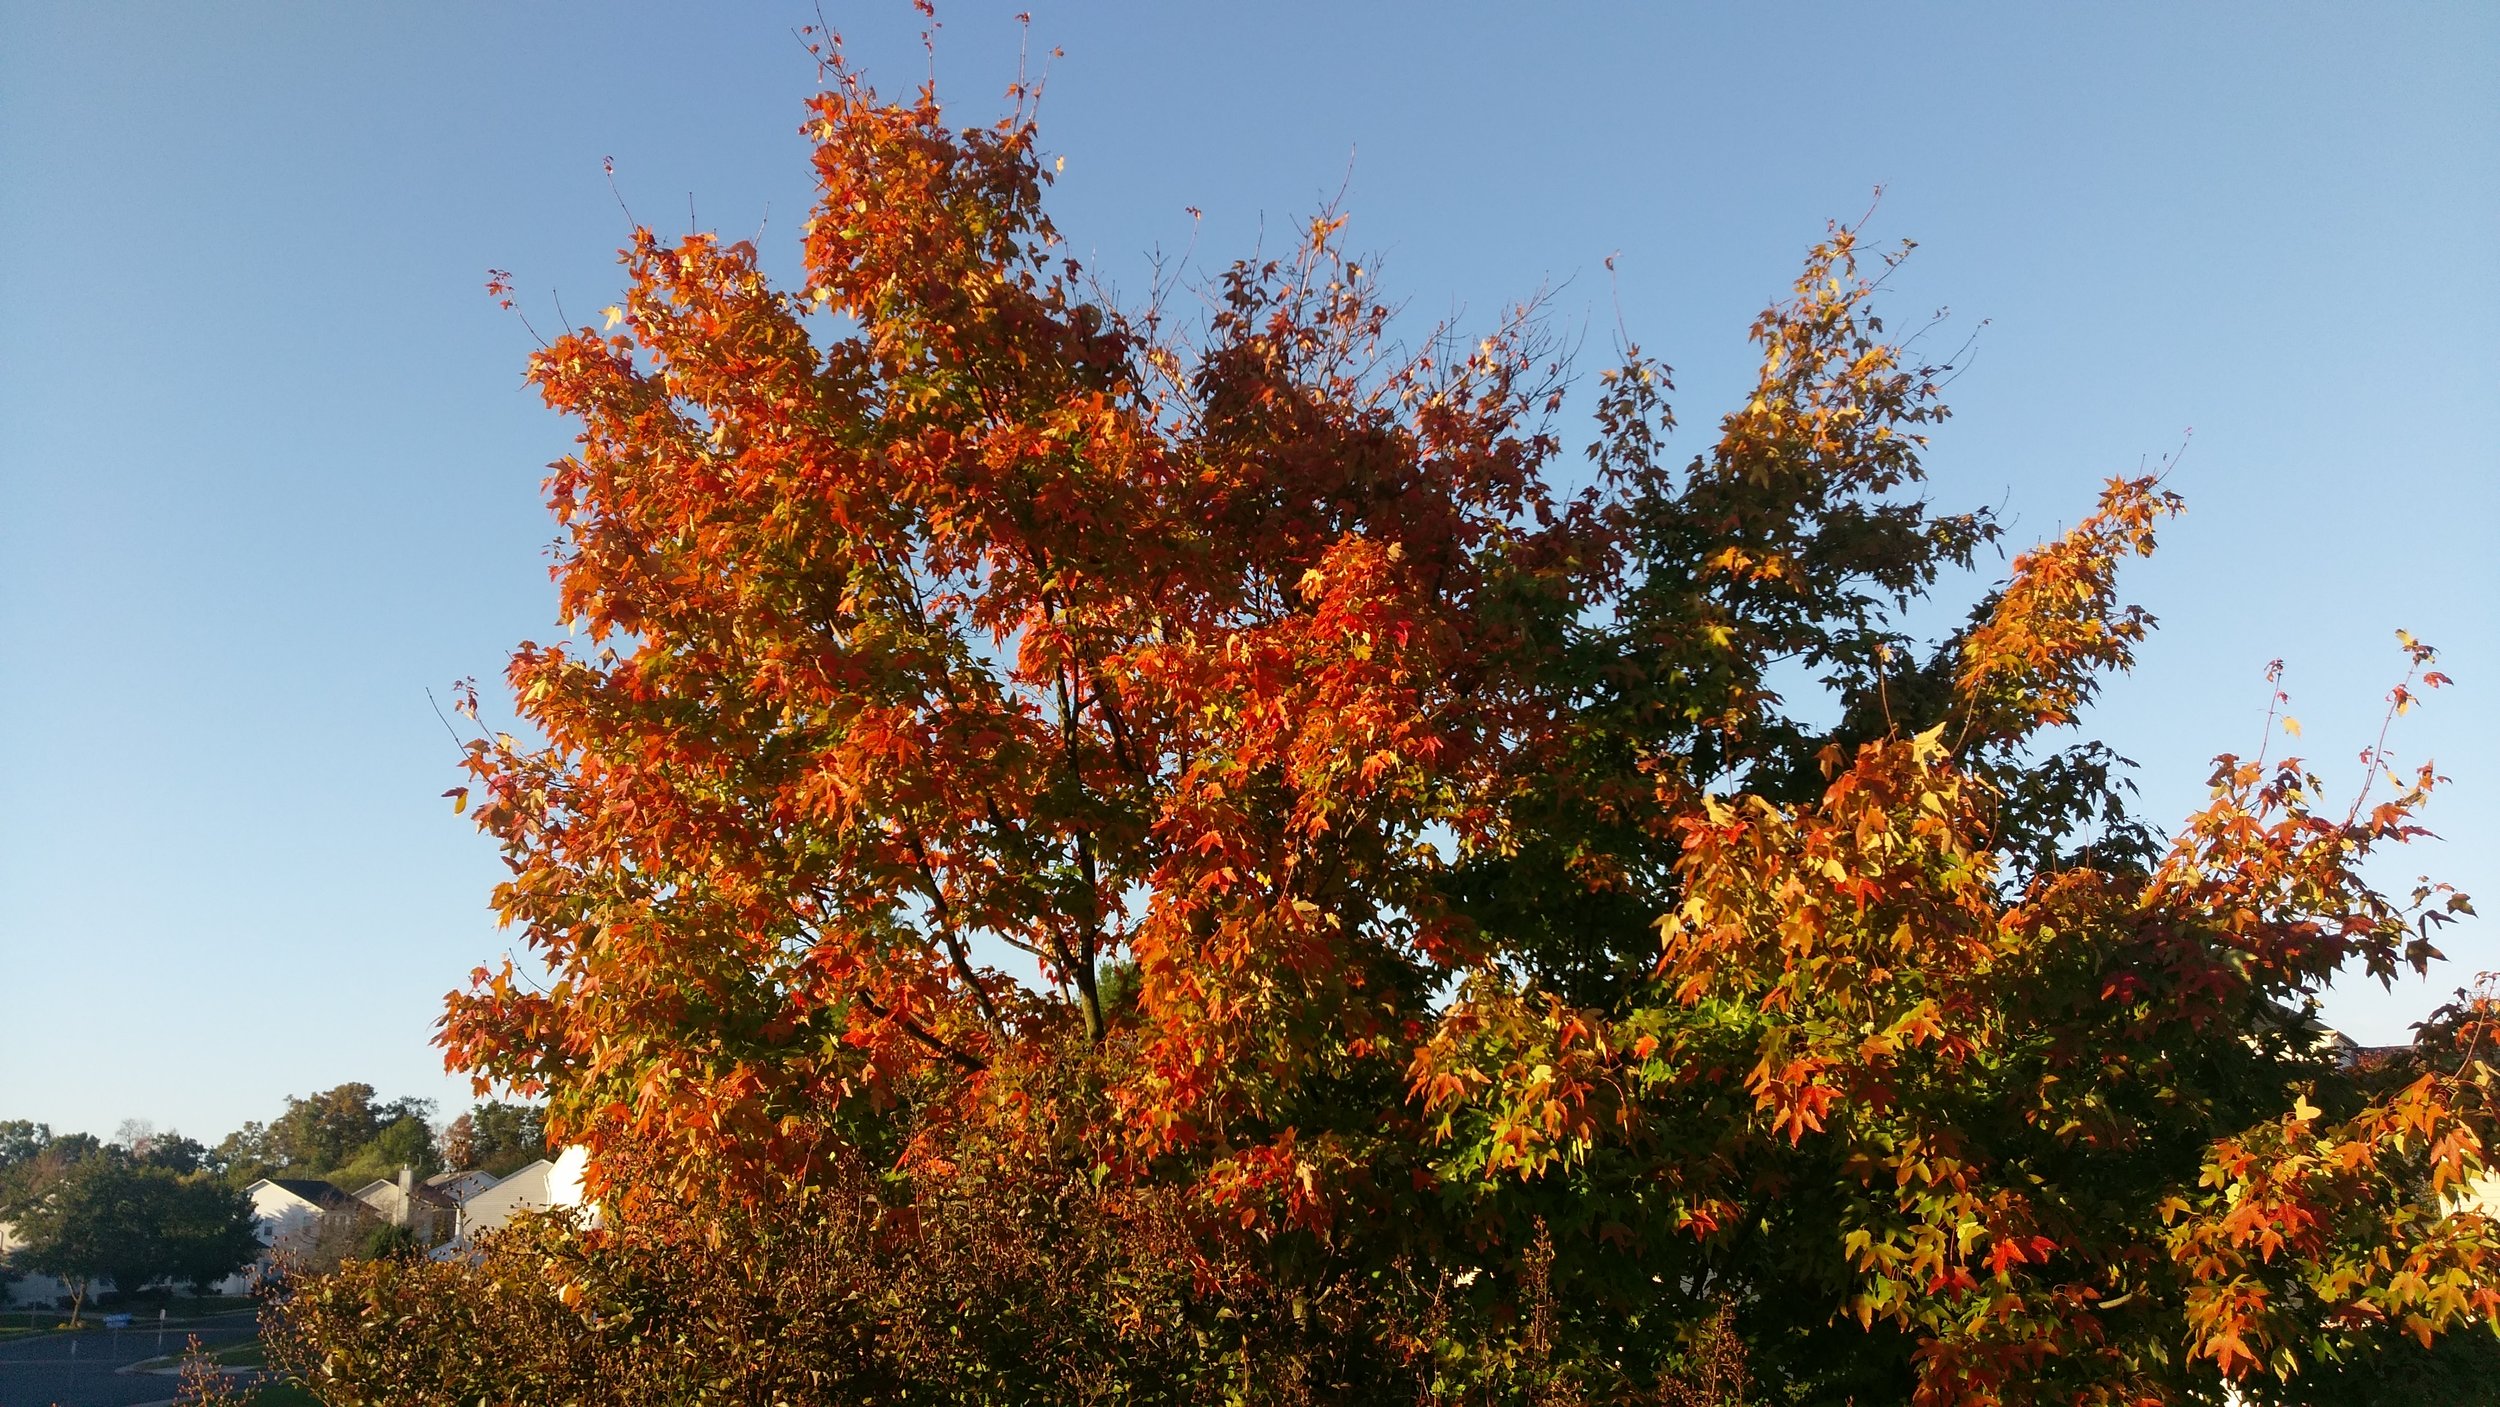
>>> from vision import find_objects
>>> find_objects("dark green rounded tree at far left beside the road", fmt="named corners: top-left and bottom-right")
top-left (15, 1152), bottom-right (260, 1325)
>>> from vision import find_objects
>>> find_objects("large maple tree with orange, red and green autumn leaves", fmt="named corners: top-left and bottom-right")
top-left (405, 38), bottom-right (2500, 1402)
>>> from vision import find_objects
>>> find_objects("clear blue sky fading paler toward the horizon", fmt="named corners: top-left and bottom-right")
top-left (0, 0), bottom-right (2500, 1140)
